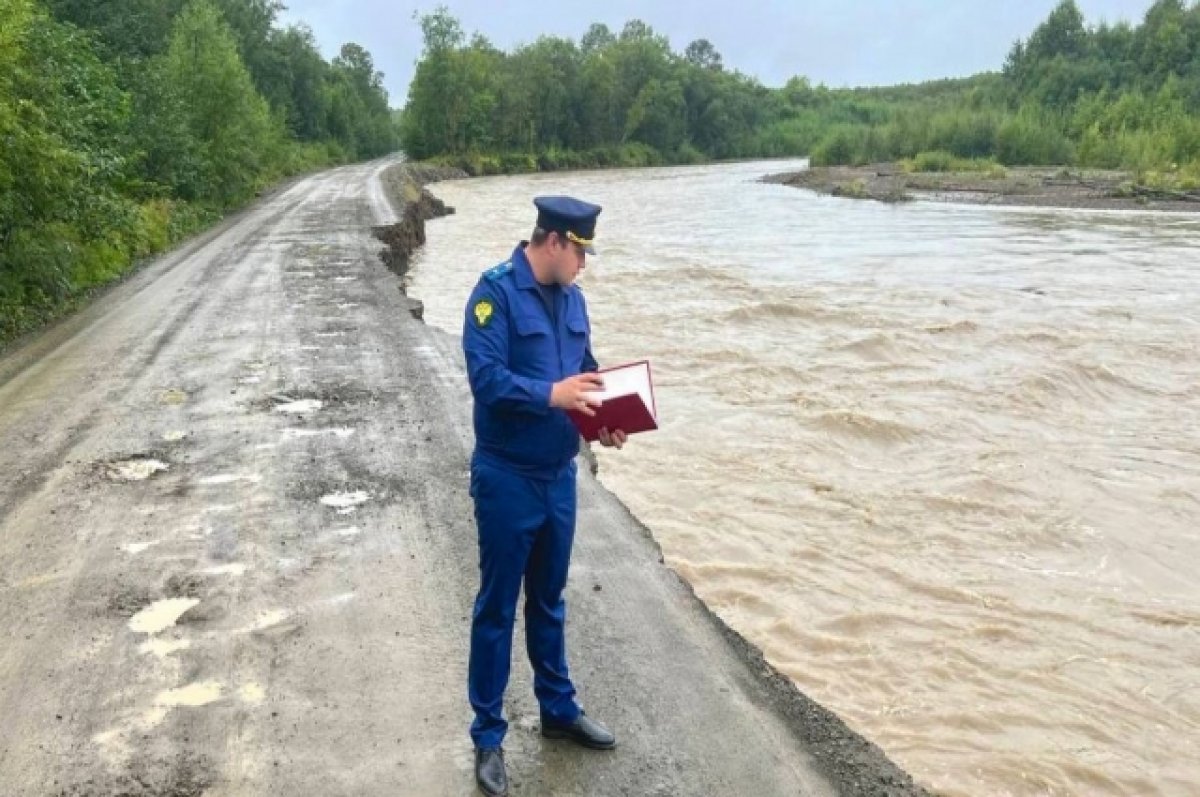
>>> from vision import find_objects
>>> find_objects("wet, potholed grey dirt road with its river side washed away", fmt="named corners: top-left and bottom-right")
top-left (0, 158), bottom-right (916, 796)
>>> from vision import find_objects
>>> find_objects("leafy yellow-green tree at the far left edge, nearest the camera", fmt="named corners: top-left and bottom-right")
top-left (0, 0), bottom-right (134, 338)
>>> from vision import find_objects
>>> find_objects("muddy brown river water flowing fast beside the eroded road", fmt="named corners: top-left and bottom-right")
top-left (412, 158), bottom-right (1200, 795)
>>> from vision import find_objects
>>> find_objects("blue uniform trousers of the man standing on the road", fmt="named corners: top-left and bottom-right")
top-left (468, 456), bottom-right (580, 748)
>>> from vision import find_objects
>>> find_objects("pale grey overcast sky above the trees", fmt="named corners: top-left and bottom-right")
top-left (276, 0), bottom-right (1151, 107)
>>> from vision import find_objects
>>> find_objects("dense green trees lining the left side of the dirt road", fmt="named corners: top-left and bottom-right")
top-left (0, 0), bottom-right (398, 343)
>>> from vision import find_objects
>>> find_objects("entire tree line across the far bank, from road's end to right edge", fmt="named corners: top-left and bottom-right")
top-left (402, 0), bottom-right (1200, 180)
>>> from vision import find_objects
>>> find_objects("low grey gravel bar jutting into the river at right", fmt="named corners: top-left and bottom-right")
top-left (763, 163), bottom-right (1200, 212)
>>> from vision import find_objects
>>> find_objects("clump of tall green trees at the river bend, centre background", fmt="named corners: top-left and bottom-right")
top-left (401, 7), bottom-right (816, 172)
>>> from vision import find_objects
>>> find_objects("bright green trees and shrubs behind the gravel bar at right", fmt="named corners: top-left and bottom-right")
top-left (812, 0), bottom-right (1200, 174)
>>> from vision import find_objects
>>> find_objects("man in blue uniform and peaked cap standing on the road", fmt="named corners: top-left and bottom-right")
top-left (462, 197), bottom-right (625, 795)
